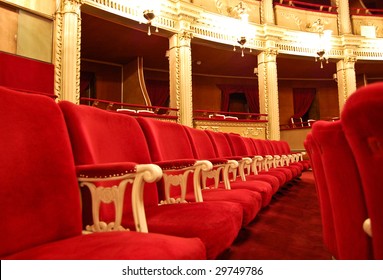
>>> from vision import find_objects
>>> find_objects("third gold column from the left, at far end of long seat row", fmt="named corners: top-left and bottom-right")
top-left (258, 46), bottom-right (281, 140)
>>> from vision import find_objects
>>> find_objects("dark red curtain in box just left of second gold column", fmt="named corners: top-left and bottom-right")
top-left (145, 80), bottom-right (170, 107)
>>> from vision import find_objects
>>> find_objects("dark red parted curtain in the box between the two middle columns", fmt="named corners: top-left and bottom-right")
top-left (218, 85), bottom-right (259, 113)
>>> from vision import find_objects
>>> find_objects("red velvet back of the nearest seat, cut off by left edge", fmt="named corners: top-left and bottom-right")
top-left (0, 87), bottom-right (82, 257)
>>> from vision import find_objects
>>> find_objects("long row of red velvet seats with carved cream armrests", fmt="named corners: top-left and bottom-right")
top-left (0, 88), bottom-right (308, 259)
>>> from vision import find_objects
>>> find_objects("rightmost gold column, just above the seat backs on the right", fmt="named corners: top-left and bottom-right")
top-left (336, 55), bottom-right (356, 112)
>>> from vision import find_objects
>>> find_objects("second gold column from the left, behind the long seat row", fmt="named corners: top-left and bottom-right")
top-left (169, 31), bottom-right (193, 127)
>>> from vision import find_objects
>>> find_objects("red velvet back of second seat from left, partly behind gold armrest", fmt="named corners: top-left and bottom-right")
top-left (59, 101), bottom-right (159, 225)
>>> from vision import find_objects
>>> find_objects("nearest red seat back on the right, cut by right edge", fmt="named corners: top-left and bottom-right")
top-left (341, 83), bottom-right (383, 260)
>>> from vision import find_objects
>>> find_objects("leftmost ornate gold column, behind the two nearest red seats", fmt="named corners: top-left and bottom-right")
top-left (55, 0), bottom-right (83, 104)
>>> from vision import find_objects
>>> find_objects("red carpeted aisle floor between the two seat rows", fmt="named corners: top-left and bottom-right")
top-left (220, 171), bottom-right (331, 260)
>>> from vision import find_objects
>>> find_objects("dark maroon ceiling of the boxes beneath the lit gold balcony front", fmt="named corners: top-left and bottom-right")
top-left (81, 0), bottom-right (383, 80)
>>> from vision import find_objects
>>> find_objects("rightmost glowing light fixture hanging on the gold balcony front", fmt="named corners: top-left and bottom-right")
top-left (308, 19), bottom-right (332, 68)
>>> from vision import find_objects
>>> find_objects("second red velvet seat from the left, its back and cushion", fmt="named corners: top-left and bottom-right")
top-left (59, 101), bottom-right (242, 259)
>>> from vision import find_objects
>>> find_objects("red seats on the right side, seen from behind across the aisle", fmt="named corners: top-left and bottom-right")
top-left (305, 83), bottom-right (383, 260)
